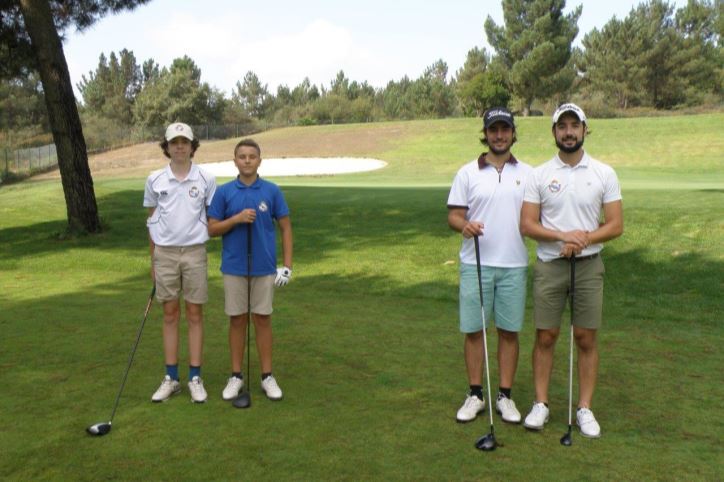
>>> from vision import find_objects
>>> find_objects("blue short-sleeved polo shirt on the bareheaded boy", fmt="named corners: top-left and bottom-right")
top-left (208, 177), bottom-right (289, 276)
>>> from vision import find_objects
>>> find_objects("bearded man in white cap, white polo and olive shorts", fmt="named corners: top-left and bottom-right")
top-left (520, 103), bottom-right (623, 438)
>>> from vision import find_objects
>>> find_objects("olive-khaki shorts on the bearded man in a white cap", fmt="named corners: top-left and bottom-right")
top-left (533, 256), bottom-right (606, 330)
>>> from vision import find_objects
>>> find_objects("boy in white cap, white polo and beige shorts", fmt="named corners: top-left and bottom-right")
top-left (143, 122), bottom-right (216, 403)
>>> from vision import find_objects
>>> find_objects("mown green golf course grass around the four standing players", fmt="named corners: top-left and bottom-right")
top-left (0, 116), bottom-right (724, 480)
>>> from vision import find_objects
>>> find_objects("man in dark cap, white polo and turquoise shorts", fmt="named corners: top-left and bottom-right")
top-left (447, 107), bottom-right (532, 423)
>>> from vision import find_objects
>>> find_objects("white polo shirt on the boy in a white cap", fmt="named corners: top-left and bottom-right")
top-left (143, 163), bottom-right (216, 246)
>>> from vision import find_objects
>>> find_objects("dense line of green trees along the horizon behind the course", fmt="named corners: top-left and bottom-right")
top-left (0, 0), bottom-right (724, 141)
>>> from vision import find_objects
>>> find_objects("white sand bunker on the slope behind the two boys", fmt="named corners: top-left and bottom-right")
top-left (199, 157), bottom-right (387, 177)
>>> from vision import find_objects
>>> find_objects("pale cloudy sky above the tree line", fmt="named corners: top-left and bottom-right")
top-left (64, 0), bottom-right (686, 95)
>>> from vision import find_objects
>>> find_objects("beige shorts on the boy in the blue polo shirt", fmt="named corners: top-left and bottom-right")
top-left (224, 274), bottom-right (275, 316)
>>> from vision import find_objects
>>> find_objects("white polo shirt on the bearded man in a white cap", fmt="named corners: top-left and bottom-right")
top-left (524, 152), bottom-right (621, 261)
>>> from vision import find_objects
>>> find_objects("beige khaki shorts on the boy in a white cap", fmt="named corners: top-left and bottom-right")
top-left (153, 244), bottom-right (209, 305)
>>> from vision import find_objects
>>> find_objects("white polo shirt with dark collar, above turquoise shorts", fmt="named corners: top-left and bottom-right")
top-left (447, 156), bottom-right (533, 268)
